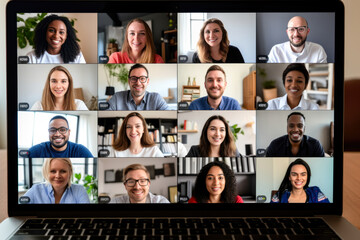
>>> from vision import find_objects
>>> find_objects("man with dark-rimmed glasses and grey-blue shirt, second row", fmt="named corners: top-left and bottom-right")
top-left (108, 63), bottom-right (168, 111)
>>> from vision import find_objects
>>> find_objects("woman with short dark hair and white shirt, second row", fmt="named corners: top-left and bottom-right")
top-left (266, 63), bottom-right (319, 110)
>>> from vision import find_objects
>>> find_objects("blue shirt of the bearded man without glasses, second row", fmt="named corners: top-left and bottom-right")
top-left (189, 96), bottom-right (241, 110)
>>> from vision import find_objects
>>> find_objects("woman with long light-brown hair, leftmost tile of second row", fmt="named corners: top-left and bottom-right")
top-left (31, 66), bottom-right (88, 111)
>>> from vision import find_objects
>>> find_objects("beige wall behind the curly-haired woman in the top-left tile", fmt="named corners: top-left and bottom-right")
top-left (18, 13), bottom-right (98, 63)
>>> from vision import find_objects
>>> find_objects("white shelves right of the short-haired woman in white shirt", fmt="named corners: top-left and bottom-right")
top-left (304, 63), bottom-right (334, 110)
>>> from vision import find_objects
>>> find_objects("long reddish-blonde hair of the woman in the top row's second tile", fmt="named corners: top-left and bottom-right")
top-left (121, 18), bottom-right (156, 63)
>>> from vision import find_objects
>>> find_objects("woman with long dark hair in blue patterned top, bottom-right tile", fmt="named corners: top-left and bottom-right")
top-left (271, 158), bottom-right (329, 203)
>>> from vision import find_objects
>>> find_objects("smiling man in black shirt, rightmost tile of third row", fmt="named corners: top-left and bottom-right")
top-left (266, 112), bottom-right (325, 157)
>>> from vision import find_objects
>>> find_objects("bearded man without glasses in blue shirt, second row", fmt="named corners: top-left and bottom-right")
top-left (189, 65), bottom-right (241, 110)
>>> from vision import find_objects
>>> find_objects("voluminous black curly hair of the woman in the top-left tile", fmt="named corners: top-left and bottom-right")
top-left (34, 14), bottom-right (80, 63)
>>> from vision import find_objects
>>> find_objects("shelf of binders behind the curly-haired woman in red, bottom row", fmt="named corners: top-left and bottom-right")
top-left (178, 156), bottom-right (256, 203)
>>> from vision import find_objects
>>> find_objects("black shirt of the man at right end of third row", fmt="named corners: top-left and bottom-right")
top-left (266, 135), bottom-right (324, 157)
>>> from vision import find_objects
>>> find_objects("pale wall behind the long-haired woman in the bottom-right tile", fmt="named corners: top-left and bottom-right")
top-left (256, 158), bottom-right (334, 202)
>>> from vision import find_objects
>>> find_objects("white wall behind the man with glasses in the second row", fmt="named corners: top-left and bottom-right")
top-left (98, 64), bottom-right (177, 99)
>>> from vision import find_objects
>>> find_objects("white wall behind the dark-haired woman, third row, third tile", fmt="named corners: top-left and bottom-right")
top-left (178, 110), bottom-right (256, 155)
